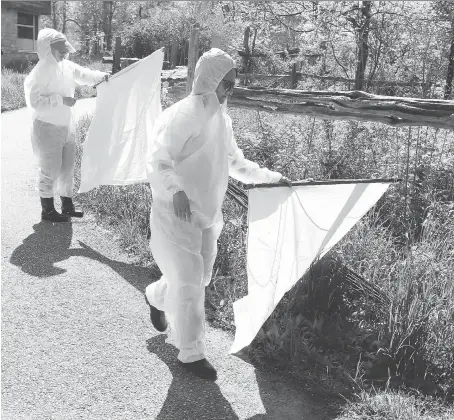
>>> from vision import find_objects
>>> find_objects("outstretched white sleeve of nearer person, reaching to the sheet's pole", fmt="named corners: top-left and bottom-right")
top-left (225, 115), bottom-right (282, 184)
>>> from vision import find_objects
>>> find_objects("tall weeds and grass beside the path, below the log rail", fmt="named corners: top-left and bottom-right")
top-left (72, 97), bottom-right (454, 420)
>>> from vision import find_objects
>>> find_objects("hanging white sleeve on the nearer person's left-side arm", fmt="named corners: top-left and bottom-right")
top-left (149, 113), bottom-right (194, 195)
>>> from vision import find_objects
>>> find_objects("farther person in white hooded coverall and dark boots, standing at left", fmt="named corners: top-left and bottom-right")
top-left (24, 28), bottom-right (109, 222)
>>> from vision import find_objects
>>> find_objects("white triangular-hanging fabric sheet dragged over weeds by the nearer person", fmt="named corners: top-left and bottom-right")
top-left (230, 183), bottom-right (389, 353)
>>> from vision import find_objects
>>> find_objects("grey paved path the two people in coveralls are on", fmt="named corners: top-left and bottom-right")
top-left (1, 99), bottom-right (332, 420)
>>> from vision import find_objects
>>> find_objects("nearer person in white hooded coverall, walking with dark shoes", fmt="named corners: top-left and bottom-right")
top-left (145, 48), bottom-right (290, 380)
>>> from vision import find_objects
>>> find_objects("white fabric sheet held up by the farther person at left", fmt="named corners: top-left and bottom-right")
top-left (79, 50), bottom-right (164, 193)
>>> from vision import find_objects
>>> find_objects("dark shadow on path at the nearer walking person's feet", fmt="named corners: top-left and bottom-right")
top-left (147, 334), bottom-right (238, 420)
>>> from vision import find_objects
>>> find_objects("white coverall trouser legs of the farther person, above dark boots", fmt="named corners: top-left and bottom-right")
top-left (32, 120), bottom-right (68, 198)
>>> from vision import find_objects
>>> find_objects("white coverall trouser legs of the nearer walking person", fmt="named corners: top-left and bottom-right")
top-left (146, 213), bottom-right (205, 363)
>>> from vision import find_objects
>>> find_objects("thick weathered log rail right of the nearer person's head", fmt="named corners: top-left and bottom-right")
top-left (229, 87), bottom-right (454, 129)
